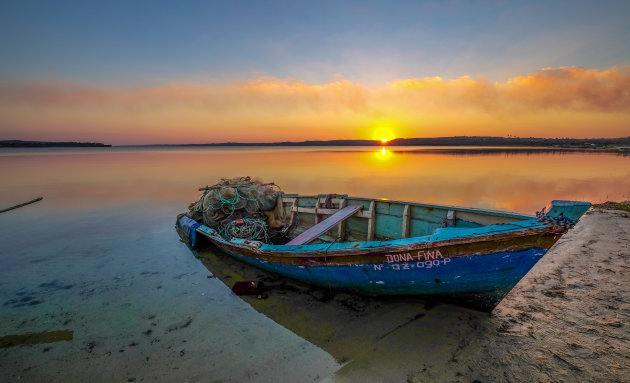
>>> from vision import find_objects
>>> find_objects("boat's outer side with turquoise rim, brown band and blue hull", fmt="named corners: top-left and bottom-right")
top-left (177, 200), bottom-right (592, 311)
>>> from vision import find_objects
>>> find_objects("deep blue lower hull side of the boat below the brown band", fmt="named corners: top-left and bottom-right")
top-left (223, 248), bottom-right (547, 309)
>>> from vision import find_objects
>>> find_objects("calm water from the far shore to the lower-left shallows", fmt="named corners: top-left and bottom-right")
top-left (0, 148), bottom-right (630, 381)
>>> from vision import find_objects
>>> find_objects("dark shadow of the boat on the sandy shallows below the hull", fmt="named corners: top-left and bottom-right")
top-left (195, 244), bottom-right (488, 364)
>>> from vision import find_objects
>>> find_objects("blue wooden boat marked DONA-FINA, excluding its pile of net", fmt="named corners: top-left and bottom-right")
top-left (176, 194), bottom-right (590, 311)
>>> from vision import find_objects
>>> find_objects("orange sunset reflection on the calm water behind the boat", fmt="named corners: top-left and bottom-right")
top-left (0, 147), bottom-right (630, 213)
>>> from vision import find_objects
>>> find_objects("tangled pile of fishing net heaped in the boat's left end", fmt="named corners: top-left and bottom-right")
top-left (186, 177), bottom-right (289, 242)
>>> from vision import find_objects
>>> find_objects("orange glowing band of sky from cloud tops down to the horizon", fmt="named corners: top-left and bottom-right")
top-left (0, 67), bottom-right (630, 143)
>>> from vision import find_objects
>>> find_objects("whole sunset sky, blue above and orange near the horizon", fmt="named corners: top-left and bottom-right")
top-left (0, 0), bottom-right (630, 145)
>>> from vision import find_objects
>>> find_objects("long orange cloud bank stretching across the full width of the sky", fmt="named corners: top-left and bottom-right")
top-left (0, 67), bottom-right (630, 113)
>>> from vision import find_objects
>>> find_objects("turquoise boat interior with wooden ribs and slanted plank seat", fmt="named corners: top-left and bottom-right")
top-left (282, 194), bottom-right (534, 245)
